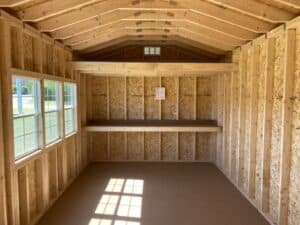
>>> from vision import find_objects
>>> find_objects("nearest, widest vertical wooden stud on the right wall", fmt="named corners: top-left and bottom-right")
top-left (278, 29), bottom-right (296, 225)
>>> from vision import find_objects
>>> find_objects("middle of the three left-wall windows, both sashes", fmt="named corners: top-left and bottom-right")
top-left (44, 80), bottom-right (60, 144)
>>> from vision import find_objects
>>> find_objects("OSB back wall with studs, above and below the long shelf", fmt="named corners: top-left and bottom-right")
top-left (85, 75), bottom-right (218, 161)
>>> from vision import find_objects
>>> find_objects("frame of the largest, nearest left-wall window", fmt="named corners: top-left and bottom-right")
top-left (11, 74), bottom-right (43, 161)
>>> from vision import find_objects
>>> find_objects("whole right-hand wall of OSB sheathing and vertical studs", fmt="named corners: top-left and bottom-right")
top-left (216, 22), bottom-right (300, 225)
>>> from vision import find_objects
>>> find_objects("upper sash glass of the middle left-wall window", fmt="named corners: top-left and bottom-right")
top-left (44, 80), bottom-right (59, 112)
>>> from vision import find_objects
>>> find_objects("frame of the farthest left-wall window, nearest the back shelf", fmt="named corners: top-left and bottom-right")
top-left (62, 81), bottom-right (78, 137)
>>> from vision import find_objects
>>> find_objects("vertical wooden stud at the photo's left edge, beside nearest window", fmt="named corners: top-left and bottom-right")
top-left (0, 19), bottom-right (20, 225)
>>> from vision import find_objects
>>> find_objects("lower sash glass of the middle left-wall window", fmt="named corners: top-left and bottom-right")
top-left (45, 111), bottom-right (59, 144)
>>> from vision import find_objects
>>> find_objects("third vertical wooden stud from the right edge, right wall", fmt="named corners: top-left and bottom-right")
top-left (248, 45), bottom-right (260, 198)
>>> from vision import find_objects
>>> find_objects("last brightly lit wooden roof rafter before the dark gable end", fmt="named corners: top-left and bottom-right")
top-left (71, 29), bottom-right (236, 51)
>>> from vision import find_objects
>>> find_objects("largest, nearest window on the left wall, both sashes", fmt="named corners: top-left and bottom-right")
top-left (12, 76), bottom-right (40, 159)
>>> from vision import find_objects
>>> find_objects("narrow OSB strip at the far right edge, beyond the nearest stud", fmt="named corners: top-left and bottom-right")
top-left (288, 26), bottom-right (300, 225)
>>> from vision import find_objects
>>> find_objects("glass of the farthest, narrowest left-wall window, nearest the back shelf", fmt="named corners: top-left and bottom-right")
top-left (64, 83), bottom-right (76, 135)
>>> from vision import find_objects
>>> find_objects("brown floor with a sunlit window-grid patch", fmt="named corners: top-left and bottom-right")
top-left (38, 162), bottom-right (268, 225)
